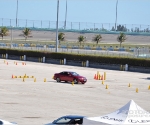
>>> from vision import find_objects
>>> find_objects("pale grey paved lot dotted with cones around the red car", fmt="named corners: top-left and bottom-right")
top-left (0, 59), bottom-right (150, 125)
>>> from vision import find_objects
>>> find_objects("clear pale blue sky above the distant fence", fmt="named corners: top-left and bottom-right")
top-left (0, 0), bottom-right (150, 28)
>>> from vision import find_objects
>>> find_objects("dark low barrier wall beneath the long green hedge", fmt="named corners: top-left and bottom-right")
top-left (0, 54), bottom-right (150, 73)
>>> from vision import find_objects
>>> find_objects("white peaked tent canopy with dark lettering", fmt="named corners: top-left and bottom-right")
top-left (83, 100), bottom-right (150, 125)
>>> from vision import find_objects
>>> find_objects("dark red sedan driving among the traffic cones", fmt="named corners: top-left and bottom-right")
top-left (54, 71), bottom-right (87, 84)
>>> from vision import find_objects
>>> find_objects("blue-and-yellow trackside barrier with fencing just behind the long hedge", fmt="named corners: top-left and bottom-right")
top-left (0, 43), bottom-right (150, 58)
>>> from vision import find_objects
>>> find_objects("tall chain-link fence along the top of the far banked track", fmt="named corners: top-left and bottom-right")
top-left (0, 18), bottom-right (150, 35)
